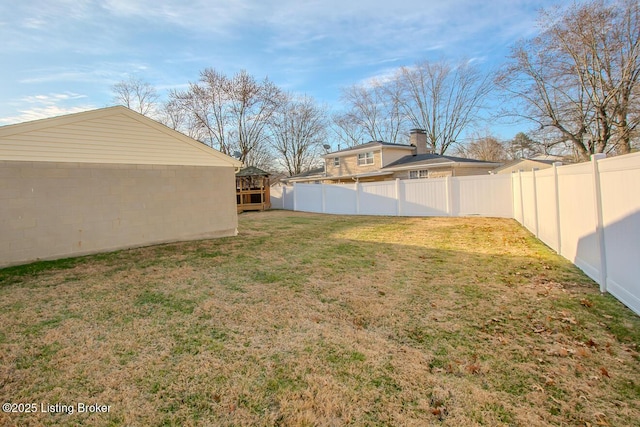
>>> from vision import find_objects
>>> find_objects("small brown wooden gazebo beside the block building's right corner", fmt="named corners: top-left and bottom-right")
top-left (236, 166), bottom-right (271, 212)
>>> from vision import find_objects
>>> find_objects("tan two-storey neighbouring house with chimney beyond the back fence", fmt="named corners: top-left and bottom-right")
top-left (289, 129), bottom-right (500, 182)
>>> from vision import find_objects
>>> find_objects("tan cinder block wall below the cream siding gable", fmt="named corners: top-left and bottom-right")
top-left (0, 161), bottom-right (238, 266)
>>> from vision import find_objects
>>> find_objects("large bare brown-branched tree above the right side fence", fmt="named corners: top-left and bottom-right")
top-left (497, 0), bottom-right (640, 159)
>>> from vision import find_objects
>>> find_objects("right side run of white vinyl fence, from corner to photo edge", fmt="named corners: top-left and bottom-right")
top-left (512, 153), bottom-right (640, 314)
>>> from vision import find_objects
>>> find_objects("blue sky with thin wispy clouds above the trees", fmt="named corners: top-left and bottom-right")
top-left (0, 0), bottom-right (559, 138)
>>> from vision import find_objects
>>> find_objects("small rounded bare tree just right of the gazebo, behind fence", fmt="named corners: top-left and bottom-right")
top-left (270, 94), bottom-right (327, 176)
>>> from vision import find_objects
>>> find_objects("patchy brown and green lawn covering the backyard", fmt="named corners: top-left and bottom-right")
top-left (0, 211), bottom-right (640, 426)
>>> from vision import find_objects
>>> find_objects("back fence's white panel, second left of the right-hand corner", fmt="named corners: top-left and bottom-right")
top-left (400, 178), bottom-right (449, 216)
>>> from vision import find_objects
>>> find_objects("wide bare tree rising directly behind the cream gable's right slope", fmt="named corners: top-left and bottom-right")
top-left (171, 68), bottom-right (283, 165)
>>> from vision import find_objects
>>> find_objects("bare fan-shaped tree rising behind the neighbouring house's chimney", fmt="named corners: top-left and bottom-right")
top-left (396, 61), bottom-right (492, 154)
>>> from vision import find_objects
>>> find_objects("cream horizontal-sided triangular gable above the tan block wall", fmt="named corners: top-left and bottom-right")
top-left (0, 106), bottom-right (242, 167)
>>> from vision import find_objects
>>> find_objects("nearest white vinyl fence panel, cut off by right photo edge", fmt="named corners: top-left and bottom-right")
top-left (596, 153), bottom-right (640, 314)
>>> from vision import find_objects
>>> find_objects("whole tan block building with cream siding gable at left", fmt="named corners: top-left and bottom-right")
top-left (0, 107), bottom-right (242, 266)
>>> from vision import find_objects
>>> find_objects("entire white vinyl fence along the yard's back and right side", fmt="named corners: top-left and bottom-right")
top-left (271, 153), bottom-right (640, 315)
